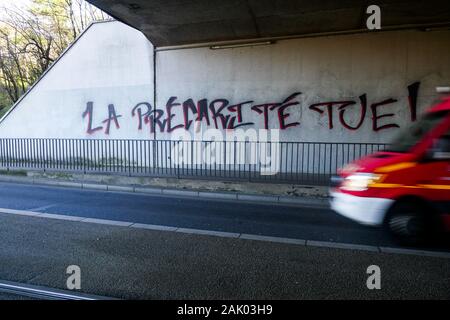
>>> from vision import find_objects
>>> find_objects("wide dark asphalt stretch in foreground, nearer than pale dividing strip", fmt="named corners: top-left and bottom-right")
top-left (0, 214), bottom-right (450, 299)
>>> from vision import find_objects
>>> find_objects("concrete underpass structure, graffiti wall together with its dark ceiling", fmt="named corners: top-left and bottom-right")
top-left (0, 0), bottom-right (450, 182)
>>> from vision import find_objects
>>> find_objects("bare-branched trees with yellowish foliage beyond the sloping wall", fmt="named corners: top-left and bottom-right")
top-left (0, 0), bottom-right (109, 115)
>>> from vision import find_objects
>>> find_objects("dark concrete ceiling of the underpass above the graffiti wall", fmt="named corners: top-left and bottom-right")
top-left (88, 0), bottom-right (450, 47)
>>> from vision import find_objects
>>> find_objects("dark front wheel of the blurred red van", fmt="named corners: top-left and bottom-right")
top-left (386, 201), bottom-right (433, 245)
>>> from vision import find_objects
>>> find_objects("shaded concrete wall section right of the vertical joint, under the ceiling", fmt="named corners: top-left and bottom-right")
top-left (156, 31), bottom-right (450, 142)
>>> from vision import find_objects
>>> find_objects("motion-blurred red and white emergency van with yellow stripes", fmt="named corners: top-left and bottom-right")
top-left (330, 88), bottom-right (450, 243)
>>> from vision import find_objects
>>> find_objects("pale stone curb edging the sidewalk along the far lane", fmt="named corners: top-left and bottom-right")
top-left (0, 175), bottom-right (329, 209)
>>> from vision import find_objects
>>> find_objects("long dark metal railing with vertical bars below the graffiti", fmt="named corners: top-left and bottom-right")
top-left (0, 138), bottom-right (387, 185)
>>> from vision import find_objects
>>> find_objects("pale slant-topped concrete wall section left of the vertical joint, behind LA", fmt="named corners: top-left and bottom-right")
top-left (0, 22), bottom-right (154, 139)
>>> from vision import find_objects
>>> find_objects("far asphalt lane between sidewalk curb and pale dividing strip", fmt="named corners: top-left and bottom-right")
top-left (0, 183), bottom-right (404, 246)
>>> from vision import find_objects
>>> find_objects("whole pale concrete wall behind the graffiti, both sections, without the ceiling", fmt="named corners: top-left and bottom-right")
top-left (0, 22), bottom-right (450, 142)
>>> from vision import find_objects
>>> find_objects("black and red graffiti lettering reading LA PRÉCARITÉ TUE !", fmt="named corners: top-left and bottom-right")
top-left (82, 82), bottom-right (420, 134)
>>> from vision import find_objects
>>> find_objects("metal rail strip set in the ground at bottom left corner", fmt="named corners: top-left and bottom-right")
top-left (0, 280), bottom-right (118, 300)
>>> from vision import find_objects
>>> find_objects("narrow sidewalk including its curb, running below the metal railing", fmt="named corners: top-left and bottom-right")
top-left (0, 171), bottom-right (329, 208)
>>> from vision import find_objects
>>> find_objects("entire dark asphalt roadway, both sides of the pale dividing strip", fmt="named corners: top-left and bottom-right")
top-left (0, 183), bottom-right (450, 299)
